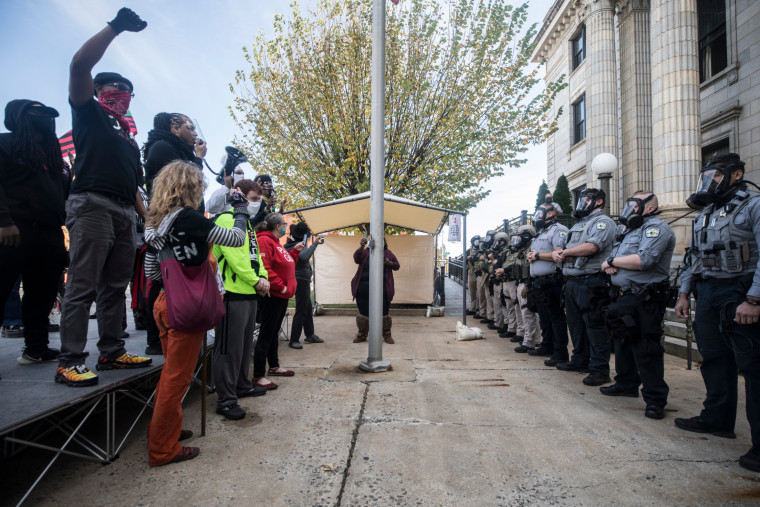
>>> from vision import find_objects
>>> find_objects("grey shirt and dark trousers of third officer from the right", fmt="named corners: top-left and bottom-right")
top-left (557, 210), bottom-right (615, 376)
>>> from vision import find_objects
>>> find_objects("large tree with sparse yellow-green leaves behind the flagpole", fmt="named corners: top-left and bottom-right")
top-left (230, 0), bottom-right (565, 210)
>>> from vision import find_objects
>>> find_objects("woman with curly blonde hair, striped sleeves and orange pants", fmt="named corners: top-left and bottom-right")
top-left (145, 161), bottom-right (248, 466)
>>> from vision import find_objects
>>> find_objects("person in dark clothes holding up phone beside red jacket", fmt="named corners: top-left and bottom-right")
top-left (285, 222), bottom-right (325, 349)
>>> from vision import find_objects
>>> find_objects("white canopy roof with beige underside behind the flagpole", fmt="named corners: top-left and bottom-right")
top-left (285, 192), bottom-right (465, 234)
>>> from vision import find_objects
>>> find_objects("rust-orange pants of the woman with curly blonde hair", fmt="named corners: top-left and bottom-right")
top-left (148, 291), bottom-right (203, 466)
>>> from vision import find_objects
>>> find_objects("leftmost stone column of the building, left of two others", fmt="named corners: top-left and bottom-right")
top-left (585, 0), bottom-right (618, 213)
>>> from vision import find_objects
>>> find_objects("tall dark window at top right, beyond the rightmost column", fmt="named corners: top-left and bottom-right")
top-left (697, 0), bottom-right (728, 82)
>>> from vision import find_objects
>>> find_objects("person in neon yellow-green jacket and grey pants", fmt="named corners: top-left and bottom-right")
top-left (213, 179), bottom-right (269, 420)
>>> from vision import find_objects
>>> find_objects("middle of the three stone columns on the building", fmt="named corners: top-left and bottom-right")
top-left (617, 0), bottom-right (657, 199)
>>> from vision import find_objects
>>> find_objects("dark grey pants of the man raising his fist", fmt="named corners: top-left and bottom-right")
top-left (58, 192), bottom-right (135, 367)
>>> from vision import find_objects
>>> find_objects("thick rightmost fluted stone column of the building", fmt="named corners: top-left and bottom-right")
top-left (651, 0), bottom-right (702, 216)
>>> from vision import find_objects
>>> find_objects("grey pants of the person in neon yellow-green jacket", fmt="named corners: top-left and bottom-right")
top-left (214, 300), bottom-right (257, 408)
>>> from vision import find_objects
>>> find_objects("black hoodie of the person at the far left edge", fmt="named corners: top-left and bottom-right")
top-left (0, 100), bottom-right (71, 227)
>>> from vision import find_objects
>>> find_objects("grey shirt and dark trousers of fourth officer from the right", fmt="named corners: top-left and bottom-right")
top-left (530, 222), bottom-right (569, 364)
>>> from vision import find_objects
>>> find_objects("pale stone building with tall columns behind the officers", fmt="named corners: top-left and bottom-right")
top-left (533, 0), bottom-right (760, 253)
